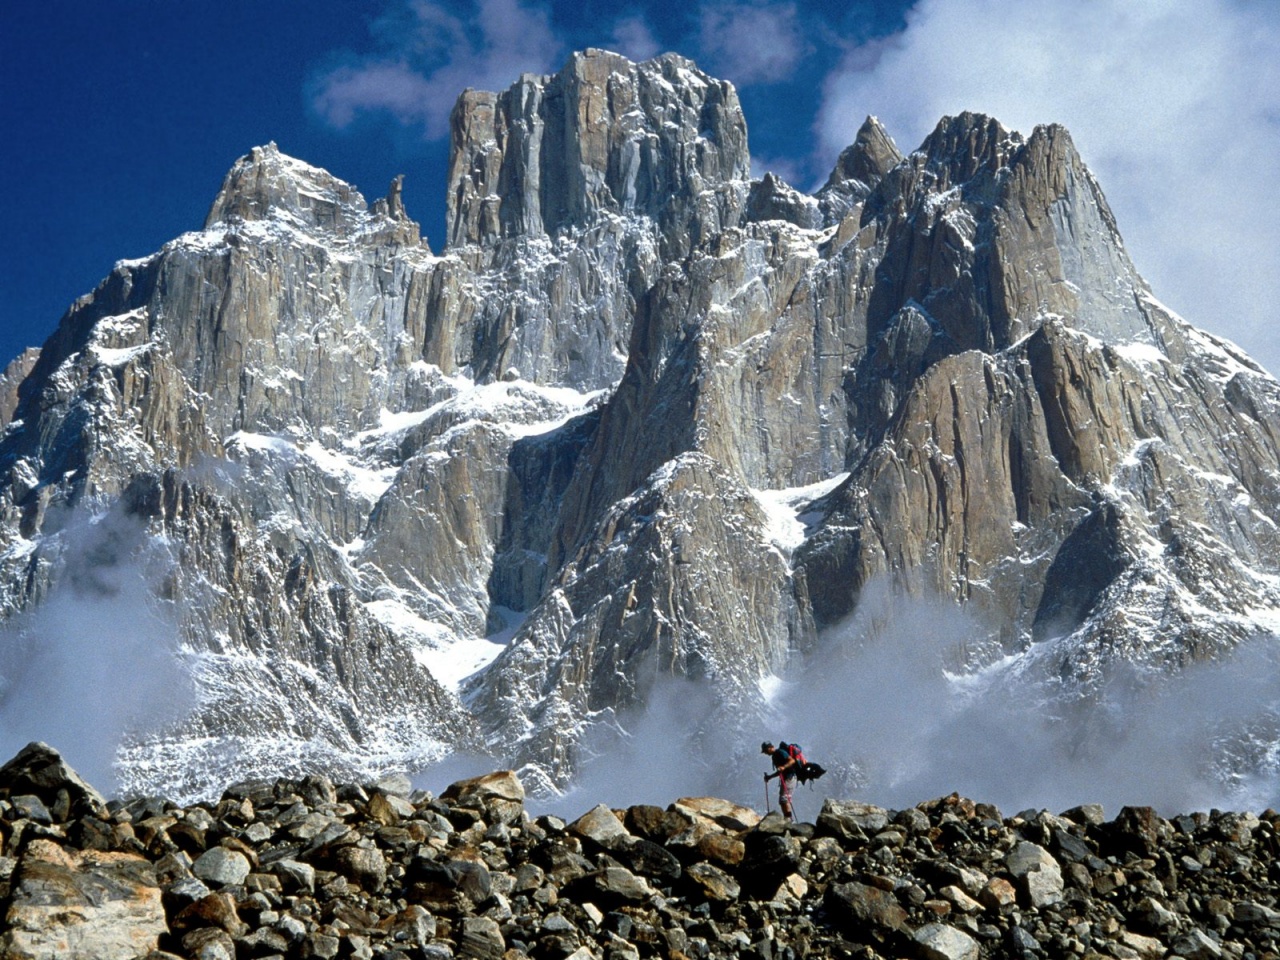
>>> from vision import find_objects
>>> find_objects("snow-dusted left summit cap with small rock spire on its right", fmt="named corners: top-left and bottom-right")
top-left (205, 142), bottom-right (417, 243)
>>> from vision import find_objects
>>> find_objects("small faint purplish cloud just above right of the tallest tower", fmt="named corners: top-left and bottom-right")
top-left (700, 3), bottom-right (804, 86)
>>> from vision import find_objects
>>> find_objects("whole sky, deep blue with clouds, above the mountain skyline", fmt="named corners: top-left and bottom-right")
top-left (0, 0), bottom-right (1280, 371)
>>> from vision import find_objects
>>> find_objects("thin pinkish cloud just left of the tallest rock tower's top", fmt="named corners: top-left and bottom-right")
top-left (311, 0), bottom-right (563, 140)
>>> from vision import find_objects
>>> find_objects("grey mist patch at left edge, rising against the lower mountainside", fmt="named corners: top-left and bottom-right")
top-left (0, 509), bottom-right (193, 796)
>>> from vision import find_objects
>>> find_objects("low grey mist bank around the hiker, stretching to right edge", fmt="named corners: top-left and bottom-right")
top-left (545, 586), bottom-right (1280, 820)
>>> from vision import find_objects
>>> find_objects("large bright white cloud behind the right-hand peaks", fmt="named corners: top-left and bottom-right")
top-left (819, 0), bottom-right (1280, 374)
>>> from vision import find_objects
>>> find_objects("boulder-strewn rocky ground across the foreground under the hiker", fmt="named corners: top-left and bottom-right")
top-left (0, 744), bottom-right (1280, 960)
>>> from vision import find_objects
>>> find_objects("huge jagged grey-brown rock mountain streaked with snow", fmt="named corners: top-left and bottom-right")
top-left (0, 50), bottom-right (1280, 796)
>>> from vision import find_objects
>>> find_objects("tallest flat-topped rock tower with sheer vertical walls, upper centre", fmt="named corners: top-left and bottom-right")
top-left (447, 50), bottom-right (750, 244)
